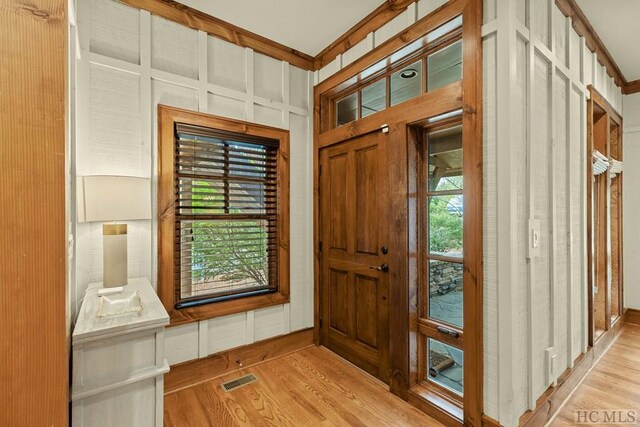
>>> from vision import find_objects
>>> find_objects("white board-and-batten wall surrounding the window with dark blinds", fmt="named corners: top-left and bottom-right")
top-left (72, 0), bottom-right (313, 364)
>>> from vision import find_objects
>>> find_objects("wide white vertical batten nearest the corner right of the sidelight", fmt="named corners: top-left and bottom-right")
top-left (496, 0), bottom-right (517, 425)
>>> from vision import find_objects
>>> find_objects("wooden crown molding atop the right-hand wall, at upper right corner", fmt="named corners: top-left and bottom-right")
top-left (556, 0), bottom-right (624, 88)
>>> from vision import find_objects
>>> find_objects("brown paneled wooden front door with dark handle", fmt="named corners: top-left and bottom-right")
top-left (320, 132), bottom-right (389, 382)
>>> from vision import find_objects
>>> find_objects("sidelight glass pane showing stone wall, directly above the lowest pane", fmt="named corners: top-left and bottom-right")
top-left (429, 260), bottom-right (463, 328)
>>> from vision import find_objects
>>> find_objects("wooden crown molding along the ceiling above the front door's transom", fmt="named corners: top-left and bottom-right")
top-left (313, 0), bottom-right (417, 70)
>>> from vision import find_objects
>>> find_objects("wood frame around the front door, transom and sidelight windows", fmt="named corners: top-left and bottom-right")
top-left (313, 0), bottom-right (484, 426)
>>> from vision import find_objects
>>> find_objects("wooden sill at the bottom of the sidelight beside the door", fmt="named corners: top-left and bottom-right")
top-left (409, 384), bottom-right (464, 426)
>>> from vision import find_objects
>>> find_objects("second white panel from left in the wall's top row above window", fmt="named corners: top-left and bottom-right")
top-left (151, 15), bottom-right (198, 79)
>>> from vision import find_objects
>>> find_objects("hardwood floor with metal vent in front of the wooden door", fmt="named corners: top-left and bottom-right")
top-left (164, 346), bottom-right (442, 427)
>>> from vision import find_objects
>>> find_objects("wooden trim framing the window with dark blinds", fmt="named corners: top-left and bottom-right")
top-left (157, 105), bottom-right (290, 326)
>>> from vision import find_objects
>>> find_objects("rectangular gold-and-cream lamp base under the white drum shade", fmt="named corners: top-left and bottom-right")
top-left (102, 224), bottom-right (128, 288)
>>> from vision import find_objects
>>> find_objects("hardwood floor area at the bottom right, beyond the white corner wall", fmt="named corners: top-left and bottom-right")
top-left (551, 323), bottom-right (640, 426)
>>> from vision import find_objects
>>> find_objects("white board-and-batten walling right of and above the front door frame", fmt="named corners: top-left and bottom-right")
top-left (316, 0), bottom-right (624, 426)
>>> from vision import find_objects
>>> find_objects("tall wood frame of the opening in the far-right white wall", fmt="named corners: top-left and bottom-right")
top-left (586, 85), bottom-right (624, 347)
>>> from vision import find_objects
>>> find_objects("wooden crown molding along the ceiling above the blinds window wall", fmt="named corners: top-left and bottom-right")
top-left (119, 0), bottom-right (314, 70)
